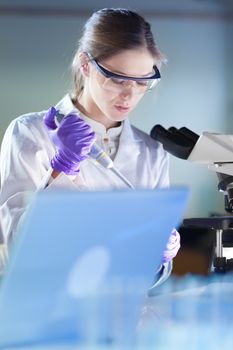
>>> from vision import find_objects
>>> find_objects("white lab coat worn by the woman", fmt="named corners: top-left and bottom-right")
top-left (0, 95), bottom-right (169, 284)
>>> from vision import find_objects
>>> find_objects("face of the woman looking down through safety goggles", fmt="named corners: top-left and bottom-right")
top-left (79, 49), bottom-right (156, 128)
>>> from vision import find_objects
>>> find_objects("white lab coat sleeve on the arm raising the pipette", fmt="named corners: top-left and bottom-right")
top-left (0, 112), bottom-right (84, 243)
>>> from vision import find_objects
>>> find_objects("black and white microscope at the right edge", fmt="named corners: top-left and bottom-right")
top-left (150, 125), bottom-right (233, 273)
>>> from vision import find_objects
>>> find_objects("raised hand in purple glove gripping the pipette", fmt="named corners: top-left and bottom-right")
top-left (44, 107), bottom-right (96, 175)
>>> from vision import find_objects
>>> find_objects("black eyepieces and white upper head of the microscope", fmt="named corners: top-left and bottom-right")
top-left (150, 125), bottom-right (233, 176)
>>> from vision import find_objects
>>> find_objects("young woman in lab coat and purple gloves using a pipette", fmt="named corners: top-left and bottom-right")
top-left (0, 8), bottom-right (180, 284)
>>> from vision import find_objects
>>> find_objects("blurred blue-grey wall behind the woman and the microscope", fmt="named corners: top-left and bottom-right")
top-left (0, 0), bottom-right (233, 221)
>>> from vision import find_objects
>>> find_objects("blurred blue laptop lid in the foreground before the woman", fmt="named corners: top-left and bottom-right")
top-left (0, 188), bottom-right (188, 349)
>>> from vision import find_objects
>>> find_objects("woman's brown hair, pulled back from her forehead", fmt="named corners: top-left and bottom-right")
top-left (72, 8), bottom-right (165, 97)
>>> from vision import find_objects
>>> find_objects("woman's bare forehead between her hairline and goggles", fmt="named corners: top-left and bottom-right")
top-left (101, 49), bottom-right (156, 76)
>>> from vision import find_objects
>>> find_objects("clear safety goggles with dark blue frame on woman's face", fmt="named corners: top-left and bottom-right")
top-left (87, 53), bottom-right (161, 94)
